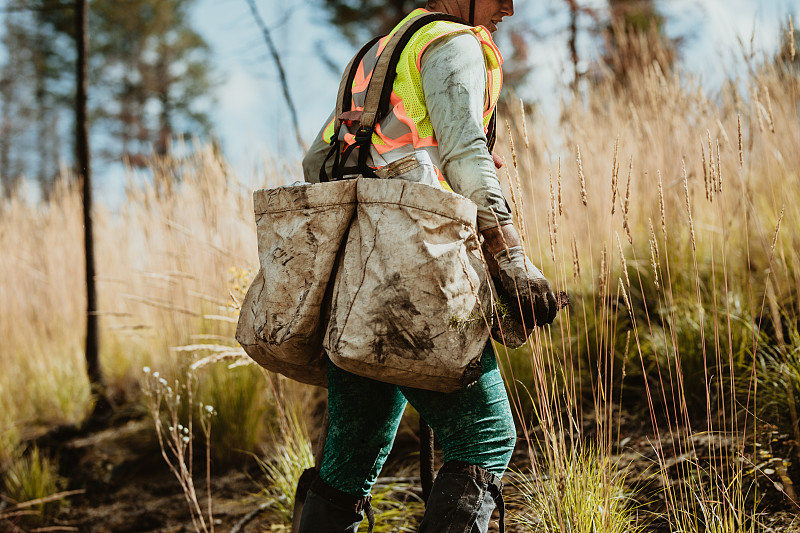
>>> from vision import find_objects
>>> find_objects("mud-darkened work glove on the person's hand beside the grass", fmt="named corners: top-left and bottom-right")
top-left (494, 246), bottom-right (558, 329)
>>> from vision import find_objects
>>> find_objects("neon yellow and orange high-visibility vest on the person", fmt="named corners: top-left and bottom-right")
top-left (323, 8), bottom-right (503, 190)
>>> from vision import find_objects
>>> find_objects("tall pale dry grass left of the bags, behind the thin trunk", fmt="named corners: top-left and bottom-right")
top-left (0, 143), bottom-right (296, 459)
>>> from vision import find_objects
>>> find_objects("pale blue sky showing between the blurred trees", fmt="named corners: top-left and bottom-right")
top-left (195, 0), bottom-right (800, 176)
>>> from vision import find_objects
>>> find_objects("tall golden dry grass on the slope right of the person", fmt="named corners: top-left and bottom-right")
top-left (501, 40), bottom-right (800, 532)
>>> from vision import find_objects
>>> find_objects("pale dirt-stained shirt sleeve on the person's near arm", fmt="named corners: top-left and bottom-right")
top-left (422, 33), bottom-right (511, 231)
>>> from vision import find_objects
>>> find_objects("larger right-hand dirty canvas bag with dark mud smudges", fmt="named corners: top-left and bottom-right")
top-left (324, 178), bottom-right (493, 392)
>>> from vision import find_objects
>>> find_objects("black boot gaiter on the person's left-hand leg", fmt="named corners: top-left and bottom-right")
top-left (298, 477), bottom-right (375, 533)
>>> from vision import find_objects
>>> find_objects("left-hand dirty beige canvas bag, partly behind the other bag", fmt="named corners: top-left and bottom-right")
top-left (236, 180), bottom-right (356, 386)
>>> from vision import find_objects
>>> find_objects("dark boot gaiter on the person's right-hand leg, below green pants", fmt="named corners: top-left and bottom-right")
top-left (419, 461), bottom-right (505, 533)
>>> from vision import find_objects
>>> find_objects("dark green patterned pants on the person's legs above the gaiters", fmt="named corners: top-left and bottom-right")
top-left (320, 342), bottom-right (516, 496)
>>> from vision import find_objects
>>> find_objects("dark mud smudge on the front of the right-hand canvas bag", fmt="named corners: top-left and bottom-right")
top-left (369, 273), bottom-right (434, 363)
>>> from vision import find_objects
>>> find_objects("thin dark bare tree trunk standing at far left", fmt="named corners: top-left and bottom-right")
top-left (75, 0), bottom-right (110, 419)
